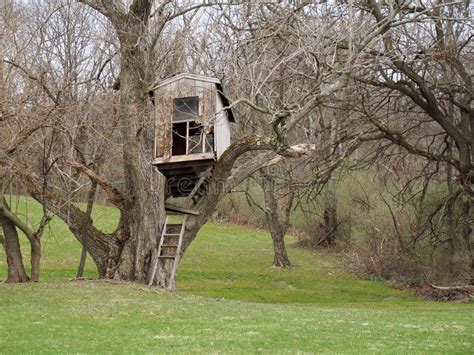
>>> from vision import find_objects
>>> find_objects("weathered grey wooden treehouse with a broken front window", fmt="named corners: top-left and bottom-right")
top-left (153, 74), bottom-right (235, 197)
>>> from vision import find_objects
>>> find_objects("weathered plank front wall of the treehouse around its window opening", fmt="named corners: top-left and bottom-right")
top-left (154, 78), bottom-right (218, 160)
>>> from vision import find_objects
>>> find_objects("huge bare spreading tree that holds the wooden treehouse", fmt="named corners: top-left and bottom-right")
top-left (2, 0), bottom-right (408, 286)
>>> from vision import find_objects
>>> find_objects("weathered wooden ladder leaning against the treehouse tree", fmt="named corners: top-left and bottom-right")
top-left (148, 215), bottom-right (188, 289)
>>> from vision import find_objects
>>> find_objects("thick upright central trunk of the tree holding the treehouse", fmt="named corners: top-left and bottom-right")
top-left (99, 16), bottom-right (171, 286)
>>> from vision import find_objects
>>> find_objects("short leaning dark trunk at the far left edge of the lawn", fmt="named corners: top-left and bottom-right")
top-left (0, 214), bottom-right (30, 283)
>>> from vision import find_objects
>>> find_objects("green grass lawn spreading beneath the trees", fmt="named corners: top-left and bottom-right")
top-left (0, 201), bottom-right (474, 353)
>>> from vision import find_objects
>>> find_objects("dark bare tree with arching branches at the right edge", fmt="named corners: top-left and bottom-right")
top-left (355, 1), bottom-right (474, 268)
